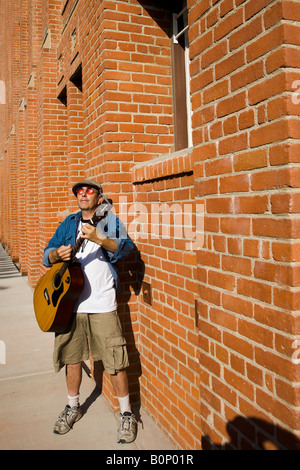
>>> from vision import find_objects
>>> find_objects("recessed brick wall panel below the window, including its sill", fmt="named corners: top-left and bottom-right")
top-left (129, 152), bottom-right (201, 449)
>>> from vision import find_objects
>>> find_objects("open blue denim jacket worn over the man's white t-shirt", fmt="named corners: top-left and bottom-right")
top-left (43, 211), bottom-right (134, 288)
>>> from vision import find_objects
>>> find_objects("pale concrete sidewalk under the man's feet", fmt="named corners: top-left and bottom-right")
top-left (0, 245), bottom-right (175, 451)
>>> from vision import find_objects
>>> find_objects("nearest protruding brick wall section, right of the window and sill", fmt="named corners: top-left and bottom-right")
top-left (189, 1), bottom-right (300, 448)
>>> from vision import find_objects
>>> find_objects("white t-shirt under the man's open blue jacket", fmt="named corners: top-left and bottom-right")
top-left (74, 222), bottom-right (117, 313)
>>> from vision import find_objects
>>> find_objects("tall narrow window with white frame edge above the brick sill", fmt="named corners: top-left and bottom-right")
top-left (172, 1), bottom-right (192, 151)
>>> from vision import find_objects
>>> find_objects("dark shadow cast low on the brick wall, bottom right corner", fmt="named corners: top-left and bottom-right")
top-left (202, 416), bottom-right (300, 450)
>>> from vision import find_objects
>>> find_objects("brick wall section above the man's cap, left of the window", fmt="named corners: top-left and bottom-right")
top-left (81, 1), bottom-right (173, 194)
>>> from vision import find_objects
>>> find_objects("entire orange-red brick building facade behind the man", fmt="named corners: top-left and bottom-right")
top-left (0, 0), bottom-right (300, 449)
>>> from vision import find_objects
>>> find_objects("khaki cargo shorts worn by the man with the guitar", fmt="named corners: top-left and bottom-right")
top-left (53, 311), bottom-right (129, 374)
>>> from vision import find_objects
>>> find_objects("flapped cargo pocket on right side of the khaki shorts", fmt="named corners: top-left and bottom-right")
top-left (104, 336), bottom-right (128, 373)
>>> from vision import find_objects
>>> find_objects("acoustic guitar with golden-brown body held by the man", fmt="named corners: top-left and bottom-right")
top-left (33, 197), bottom-right (112, 333)
